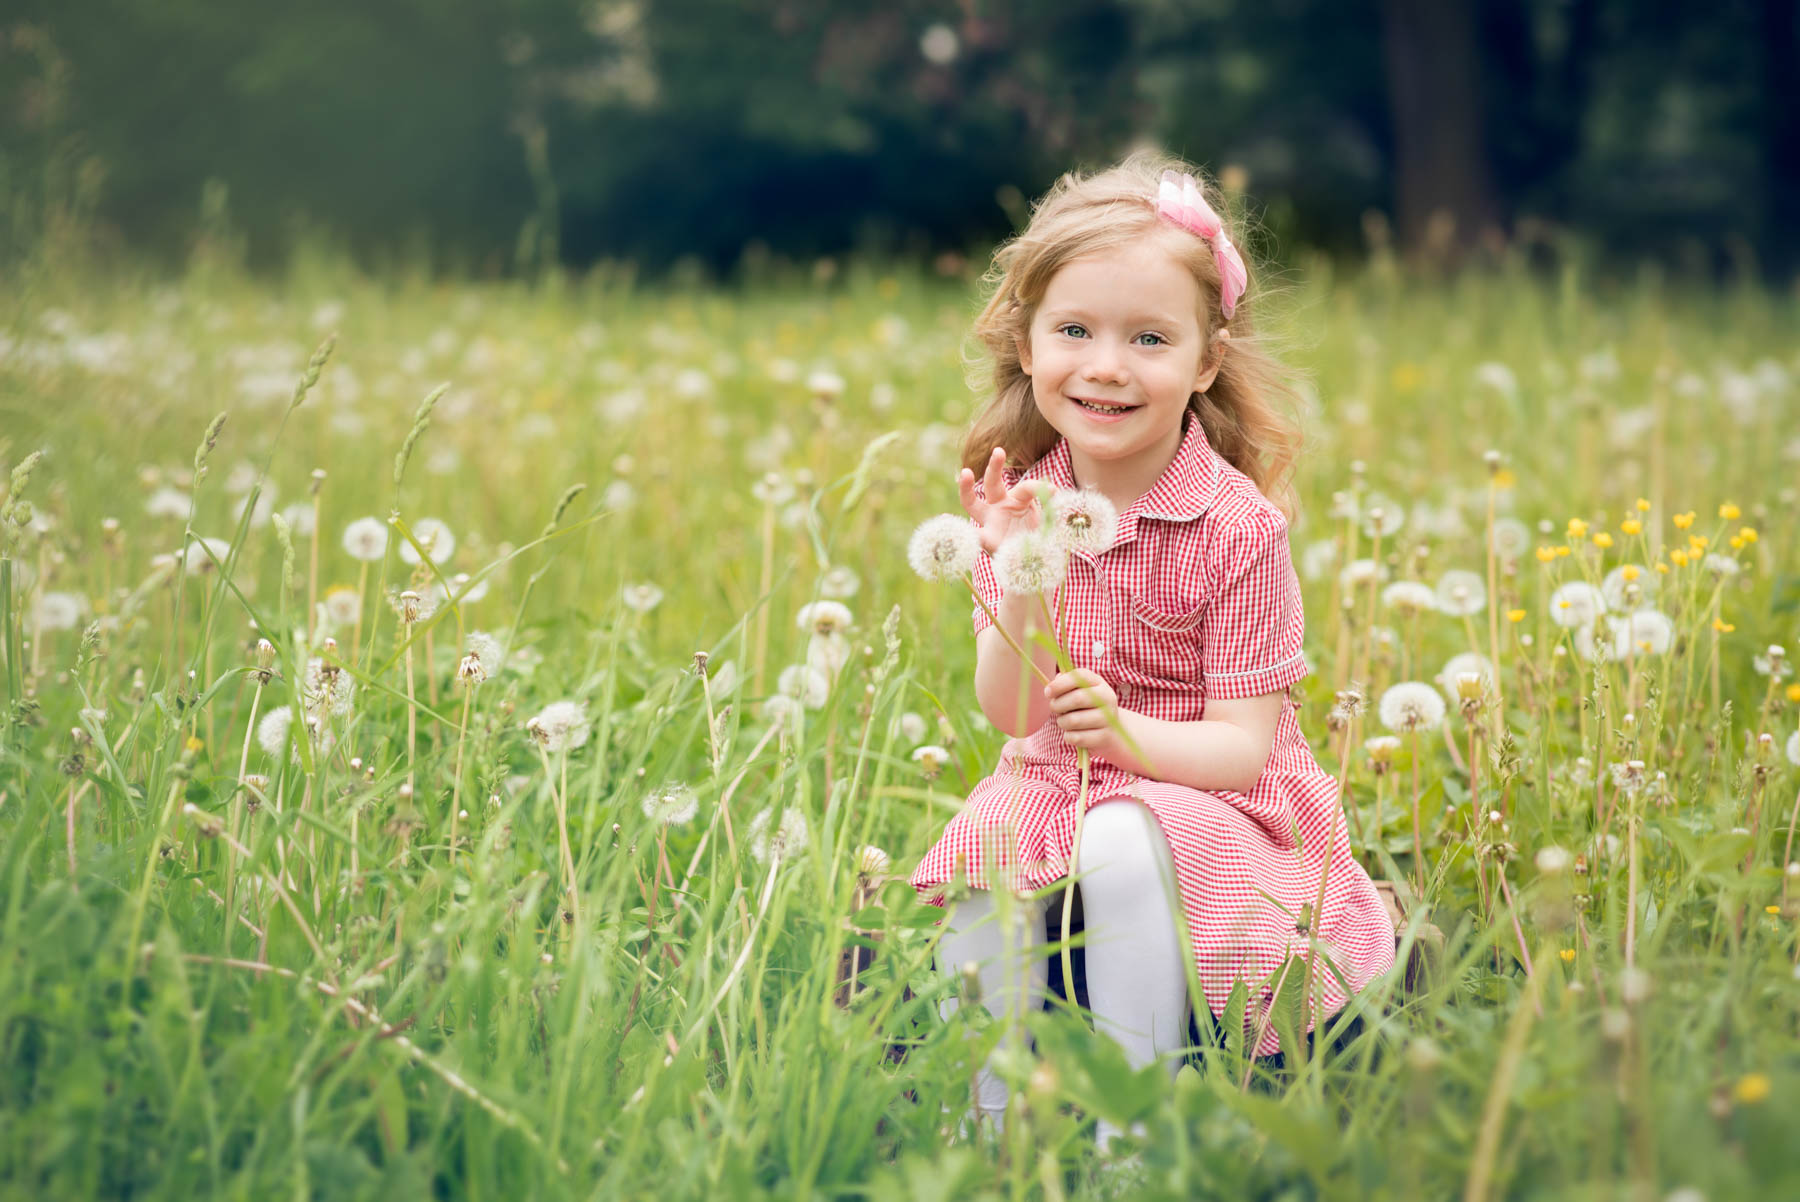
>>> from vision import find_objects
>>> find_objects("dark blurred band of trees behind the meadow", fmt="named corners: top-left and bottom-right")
top-left (0, 0), bottom-right (1800, 281)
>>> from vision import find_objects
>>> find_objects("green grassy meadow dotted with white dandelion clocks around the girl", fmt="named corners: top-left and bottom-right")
top-left (0, 246), bottom-right (1800, 1202)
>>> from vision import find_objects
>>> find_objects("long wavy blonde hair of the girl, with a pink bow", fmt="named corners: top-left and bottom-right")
top-left (963, 151), bottom-right (1301, 518)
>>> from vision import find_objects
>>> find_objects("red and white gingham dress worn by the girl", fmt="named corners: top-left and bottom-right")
top-left (911, 412), bottom-right (1393, 1056)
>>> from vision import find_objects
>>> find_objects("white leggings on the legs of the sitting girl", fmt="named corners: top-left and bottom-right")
top-left (938, 801), bottom-right (1188, 1150)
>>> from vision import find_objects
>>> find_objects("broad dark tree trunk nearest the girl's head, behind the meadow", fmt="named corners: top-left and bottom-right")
top-left (1382, 0), bottom-right (1499, 259)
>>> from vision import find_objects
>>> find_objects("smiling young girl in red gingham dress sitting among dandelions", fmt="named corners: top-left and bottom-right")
top-left (911, 153), bottom-right (1395, 1148)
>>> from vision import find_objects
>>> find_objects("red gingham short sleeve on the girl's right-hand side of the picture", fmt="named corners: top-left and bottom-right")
top-left (1201, 513), bottom-right (1310, 700)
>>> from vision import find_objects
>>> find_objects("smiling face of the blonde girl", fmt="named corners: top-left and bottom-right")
top-left (1019, 236), bottom-right (1226, 488)
